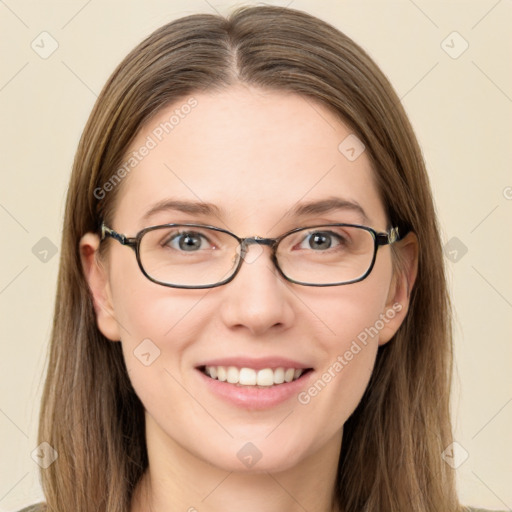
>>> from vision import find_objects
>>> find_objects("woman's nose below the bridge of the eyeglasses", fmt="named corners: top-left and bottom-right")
top-left (220, 243), bottom-right (295, 335)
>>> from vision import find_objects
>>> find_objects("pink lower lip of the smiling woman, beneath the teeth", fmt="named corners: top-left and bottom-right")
top-left (196, 369), bottom-right (313, 410)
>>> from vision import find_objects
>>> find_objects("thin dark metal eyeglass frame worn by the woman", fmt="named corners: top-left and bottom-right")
top-left (100, 222), bottom-right (407, 290)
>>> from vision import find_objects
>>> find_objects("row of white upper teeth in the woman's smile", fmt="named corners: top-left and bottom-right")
top-left (205, 366), bottom-right (304, 387)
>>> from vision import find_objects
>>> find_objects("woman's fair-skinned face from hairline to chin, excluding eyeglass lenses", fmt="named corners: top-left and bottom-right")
top-left (82, 86), bottom-right (407, 471)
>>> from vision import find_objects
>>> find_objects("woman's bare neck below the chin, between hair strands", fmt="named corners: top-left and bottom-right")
top-left (131, 418), bottom-right (341, 512)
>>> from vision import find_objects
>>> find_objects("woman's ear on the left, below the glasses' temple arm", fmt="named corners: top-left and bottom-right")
top-left (80, 233), bottom-right (121, 341)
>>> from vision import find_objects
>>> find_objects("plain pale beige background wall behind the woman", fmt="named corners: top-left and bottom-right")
top-left (0, 0), bottom-right (512, 511)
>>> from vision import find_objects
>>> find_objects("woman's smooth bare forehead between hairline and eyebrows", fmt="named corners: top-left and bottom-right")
top-left (111, 85), bottom-right (385, 234)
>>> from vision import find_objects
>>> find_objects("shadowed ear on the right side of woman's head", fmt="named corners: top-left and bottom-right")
top-left (379, 232), bottom-right (418, 345)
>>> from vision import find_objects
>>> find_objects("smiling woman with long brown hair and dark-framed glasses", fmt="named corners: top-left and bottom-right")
top-left (21, 7), bottom-right (500, 512)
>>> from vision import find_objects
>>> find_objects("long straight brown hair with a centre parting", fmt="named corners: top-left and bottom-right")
top-left (39, 6), bottom-right (459, 512)
